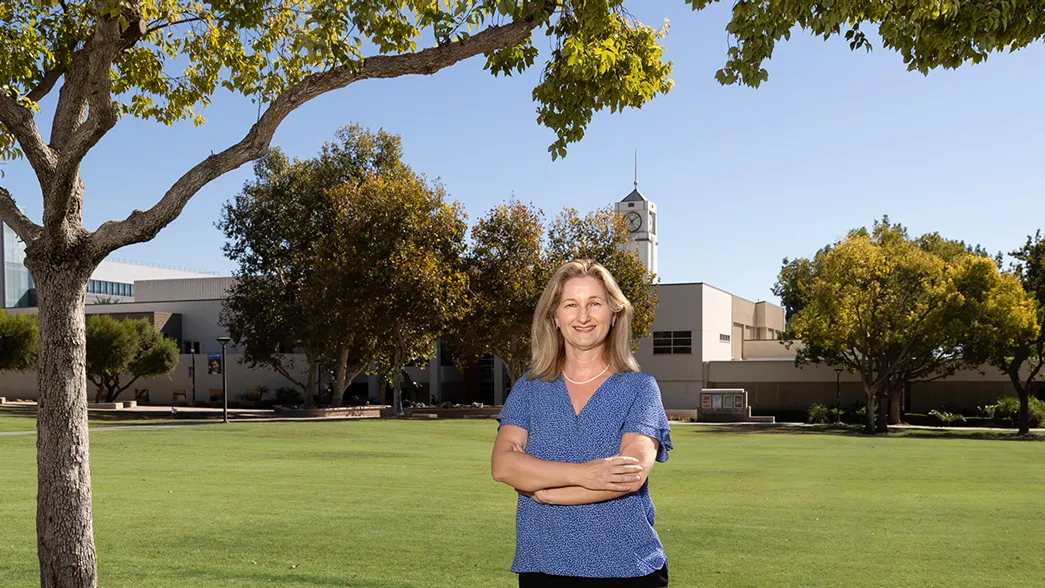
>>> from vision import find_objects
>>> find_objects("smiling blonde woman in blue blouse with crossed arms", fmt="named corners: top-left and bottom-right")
top-left (491, 260), bottom-right (672, 588)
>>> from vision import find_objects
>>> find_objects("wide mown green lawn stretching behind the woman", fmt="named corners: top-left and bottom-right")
top-left (0, 421), bottom-right (1045, 588)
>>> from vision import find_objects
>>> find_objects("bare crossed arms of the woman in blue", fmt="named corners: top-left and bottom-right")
top-left (490, 425), bottom-right (657, 504)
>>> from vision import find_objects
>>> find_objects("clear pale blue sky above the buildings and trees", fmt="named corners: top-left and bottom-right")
top-left (0, 0), bottom-right (1045, 301)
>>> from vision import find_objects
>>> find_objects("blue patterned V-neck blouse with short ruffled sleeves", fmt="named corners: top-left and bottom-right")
top-left (497, 372), bottom-right (672, 578)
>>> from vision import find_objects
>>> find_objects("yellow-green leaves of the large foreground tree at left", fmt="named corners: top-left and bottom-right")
top-left (0, 0), bottom-right (671, 159)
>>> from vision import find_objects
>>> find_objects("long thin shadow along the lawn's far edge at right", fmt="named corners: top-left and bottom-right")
top-left (694, 423), bottom-right (1045, 442)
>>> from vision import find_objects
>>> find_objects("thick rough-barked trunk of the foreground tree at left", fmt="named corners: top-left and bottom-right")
top-left (29, 259), bottom-right (100, 588)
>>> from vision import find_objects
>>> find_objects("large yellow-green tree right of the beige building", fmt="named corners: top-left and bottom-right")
top-left (774, 218), bottom-right (1024, 433)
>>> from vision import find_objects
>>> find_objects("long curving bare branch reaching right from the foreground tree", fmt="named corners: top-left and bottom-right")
top-left (91, 13), bottom-right (536, 256)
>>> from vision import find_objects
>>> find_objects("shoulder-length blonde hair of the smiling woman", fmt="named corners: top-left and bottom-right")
top-left (528, 259), bottom-right (640, 382)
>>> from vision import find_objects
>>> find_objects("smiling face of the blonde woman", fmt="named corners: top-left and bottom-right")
top-left (555, 276), bottom-right (613, 351)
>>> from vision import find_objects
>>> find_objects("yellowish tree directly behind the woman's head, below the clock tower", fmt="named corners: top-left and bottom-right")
top-left (548, 208), bottom-right (658, 345)
